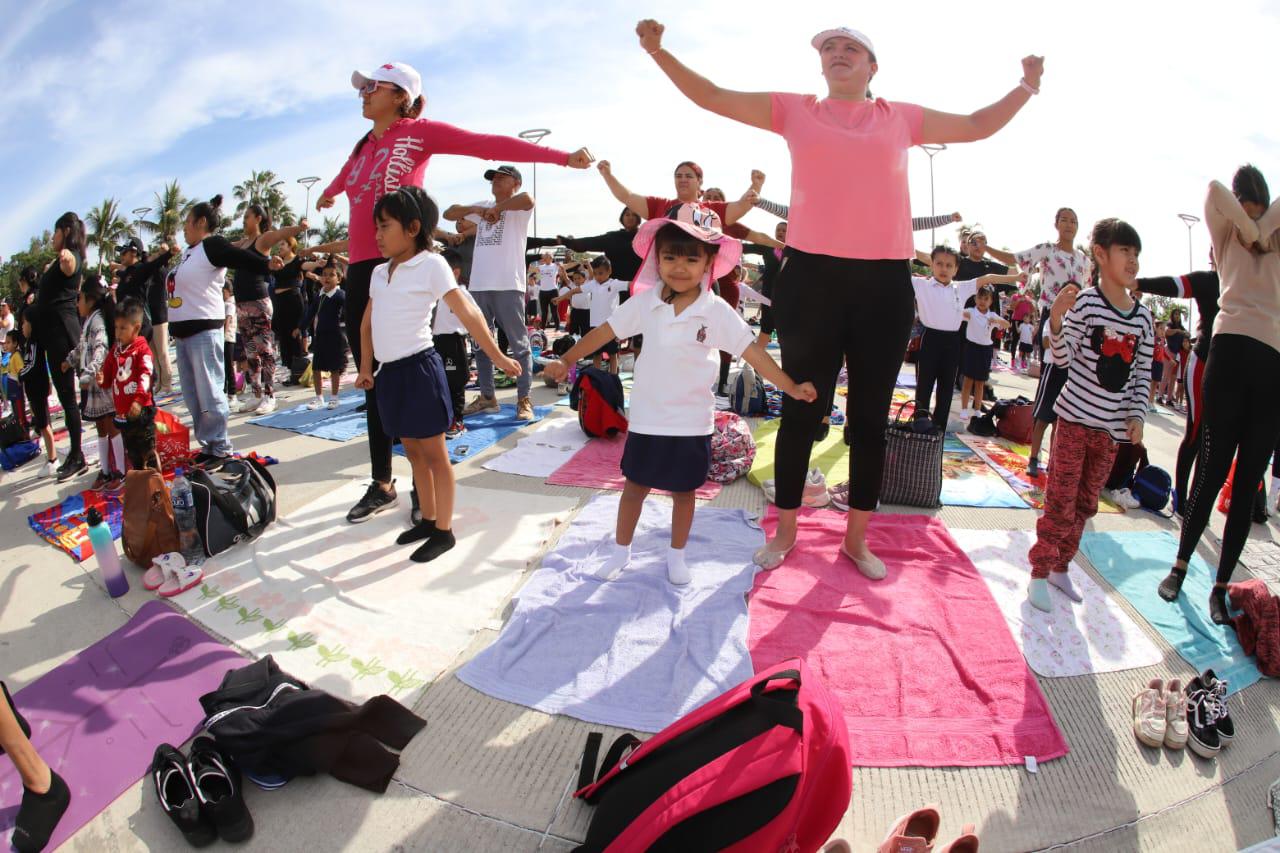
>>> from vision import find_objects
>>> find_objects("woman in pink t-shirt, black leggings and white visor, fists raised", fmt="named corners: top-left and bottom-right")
top-left (636, 20), bottom-right (1044, 579)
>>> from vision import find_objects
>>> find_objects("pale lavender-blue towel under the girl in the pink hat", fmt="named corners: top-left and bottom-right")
top-left (458, 494), bottom-right (762, 731)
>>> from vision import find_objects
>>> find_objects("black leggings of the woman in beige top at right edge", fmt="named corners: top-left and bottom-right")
top-left (1178, 334), bottom-right (1280, 584)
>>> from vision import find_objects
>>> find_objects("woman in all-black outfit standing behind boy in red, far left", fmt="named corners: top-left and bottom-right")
top-left (32, 211), bottom-right (88, 483)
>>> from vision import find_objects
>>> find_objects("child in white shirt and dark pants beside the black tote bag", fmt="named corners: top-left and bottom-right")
top-left (911, 246), bottom-right (1020, 430)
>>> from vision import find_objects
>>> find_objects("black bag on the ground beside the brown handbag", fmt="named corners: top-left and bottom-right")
top-left (189, 459), bottom-right (275, 557)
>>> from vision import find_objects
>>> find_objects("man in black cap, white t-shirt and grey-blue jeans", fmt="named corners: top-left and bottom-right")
top-left (444, 165), bottom-right (534, 420)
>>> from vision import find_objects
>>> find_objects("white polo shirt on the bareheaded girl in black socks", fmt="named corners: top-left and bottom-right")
top-left (369, 252), bottom-right (458, 364)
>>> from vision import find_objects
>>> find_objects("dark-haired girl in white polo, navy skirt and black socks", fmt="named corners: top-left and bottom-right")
top-left (356, 187), bottom-right (520, 562)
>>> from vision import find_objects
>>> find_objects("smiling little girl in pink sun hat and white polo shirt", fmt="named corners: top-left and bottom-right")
top-left (545, 219), bottom-right (818, 585)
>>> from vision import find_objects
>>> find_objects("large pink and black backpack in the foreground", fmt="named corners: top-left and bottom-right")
top-left (573, 658), bottom-right (854, 853)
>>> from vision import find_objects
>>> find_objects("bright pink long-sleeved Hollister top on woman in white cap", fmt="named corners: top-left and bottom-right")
top-left (324, 118), bottom-right (568, 263)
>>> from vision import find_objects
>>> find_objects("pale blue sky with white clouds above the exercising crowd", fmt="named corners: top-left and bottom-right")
top-left (0, 0), bottom-right (1280, 274)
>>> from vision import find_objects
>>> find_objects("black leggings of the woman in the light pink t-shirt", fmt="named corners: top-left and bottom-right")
top-left (773, 248), bottom-right (915, 511)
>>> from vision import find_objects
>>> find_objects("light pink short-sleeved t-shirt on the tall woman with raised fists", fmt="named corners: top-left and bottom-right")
top-left (773, 92), bottom-right (924, 260)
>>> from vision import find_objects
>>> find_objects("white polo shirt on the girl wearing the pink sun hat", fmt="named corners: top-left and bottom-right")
top-left (608, 287), bottom-right (755, 435)
